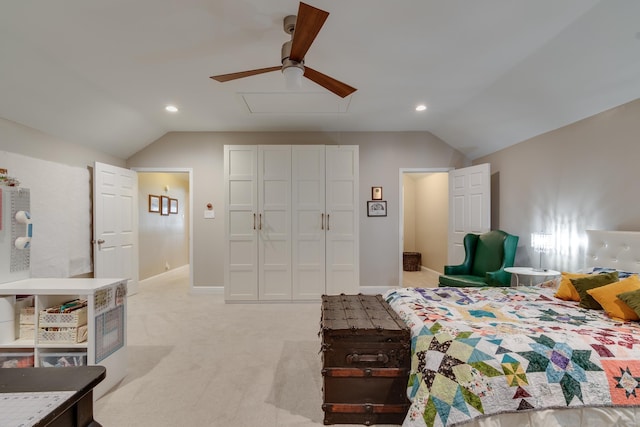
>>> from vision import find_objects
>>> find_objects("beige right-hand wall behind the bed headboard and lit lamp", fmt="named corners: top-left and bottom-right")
top-left (474, 100), bottom-right (640, 270)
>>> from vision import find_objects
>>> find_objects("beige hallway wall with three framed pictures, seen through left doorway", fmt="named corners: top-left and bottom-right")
top-left (138, 172), bottom-right (189, 280)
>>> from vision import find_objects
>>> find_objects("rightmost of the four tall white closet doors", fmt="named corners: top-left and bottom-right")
top-left (325, 145), bottom-right (360, 295)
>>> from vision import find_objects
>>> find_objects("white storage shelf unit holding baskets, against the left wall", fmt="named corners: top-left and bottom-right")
top-left (0, 278), bottom-right (127, 399)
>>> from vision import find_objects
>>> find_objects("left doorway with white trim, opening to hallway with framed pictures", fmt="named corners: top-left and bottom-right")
top-left (133, 168), bottom-right (193, 289)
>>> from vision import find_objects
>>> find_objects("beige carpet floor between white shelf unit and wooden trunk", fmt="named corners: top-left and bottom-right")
top-left (94, 269), bottom-right (416, 427)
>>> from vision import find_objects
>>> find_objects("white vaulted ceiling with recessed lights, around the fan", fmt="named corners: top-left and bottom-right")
top-left (0, 0), bottom-right (640, 159)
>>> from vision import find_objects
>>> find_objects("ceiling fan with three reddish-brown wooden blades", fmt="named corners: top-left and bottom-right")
top-left (211, 2), bottom-right (357, 98)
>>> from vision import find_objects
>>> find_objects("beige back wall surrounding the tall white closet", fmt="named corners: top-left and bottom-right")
top-left (127, 132), bottom-right (465, 287)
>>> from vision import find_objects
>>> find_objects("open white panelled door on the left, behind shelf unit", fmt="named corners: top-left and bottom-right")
top-left (93, 162), bottom-right (138, 294)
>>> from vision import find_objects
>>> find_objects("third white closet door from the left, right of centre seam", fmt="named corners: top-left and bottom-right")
top-left (291, 145), bottom-right (326, 300)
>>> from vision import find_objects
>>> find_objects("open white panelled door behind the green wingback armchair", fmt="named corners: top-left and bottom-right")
top-left (448, 163), bottom-right (491, 265)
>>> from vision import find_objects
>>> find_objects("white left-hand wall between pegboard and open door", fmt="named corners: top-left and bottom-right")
top-left (0, 118), bottom-right (125, 277)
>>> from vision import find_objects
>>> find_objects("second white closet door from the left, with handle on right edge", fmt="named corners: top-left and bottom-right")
top-left (258, 145), bottom-right (292, 300)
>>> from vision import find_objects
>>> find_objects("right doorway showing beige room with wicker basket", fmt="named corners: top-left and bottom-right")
top-left (399, 168), bottom-right (450, 286)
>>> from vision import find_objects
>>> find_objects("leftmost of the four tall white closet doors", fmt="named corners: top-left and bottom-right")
top-left (224, 145), bottom-right (258, 300)
